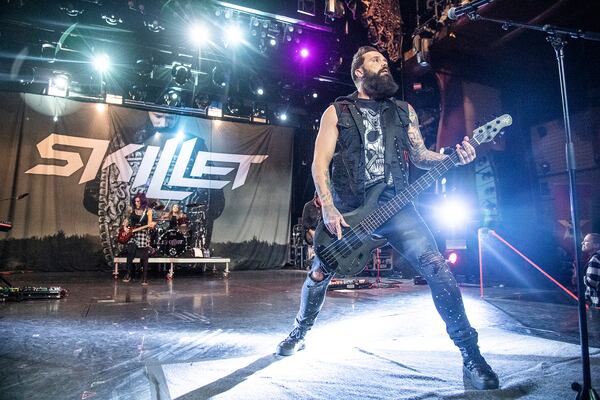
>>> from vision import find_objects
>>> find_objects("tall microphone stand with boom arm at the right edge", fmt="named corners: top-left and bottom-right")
top-left (467, 10), bottom-right (600, 400)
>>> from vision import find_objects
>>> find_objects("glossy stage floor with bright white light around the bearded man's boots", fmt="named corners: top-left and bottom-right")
top-left (0, 270), bottom-right (600, 400)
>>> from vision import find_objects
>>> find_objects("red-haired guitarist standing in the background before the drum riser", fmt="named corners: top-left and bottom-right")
top-left (123, 193), bottom-right (154, 286)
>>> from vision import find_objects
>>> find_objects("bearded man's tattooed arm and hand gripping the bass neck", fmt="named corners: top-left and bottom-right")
top-left (408, 104), bottom-right (476, 169)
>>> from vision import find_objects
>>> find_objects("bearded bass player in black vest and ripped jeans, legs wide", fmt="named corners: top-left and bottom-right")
top-left (276, 46), bottom-right (499, 389)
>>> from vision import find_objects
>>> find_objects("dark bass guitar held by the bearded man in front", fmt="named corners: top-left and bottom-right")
top-left (314, 114), bottom-right (512, 277)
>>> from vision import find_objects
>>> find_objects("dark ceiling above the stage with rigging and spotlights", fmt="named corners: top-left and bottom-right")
top-left (0, 0), bottom-right (600, 125)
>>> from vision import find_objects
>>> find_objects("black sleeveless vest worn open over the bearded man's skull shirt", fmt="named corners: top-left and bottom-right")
top-left (331, 92), bottom-right (410, 212)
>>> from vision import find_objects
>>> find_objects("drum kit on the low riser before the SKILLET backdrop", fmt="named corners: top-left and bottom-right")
top-left (150, 202), bottom-right (208, 257)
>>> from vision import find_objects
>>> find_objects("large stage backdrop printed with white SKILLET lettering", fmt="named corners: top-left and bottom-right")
top-left (0, 93), bottom-right (293, 270)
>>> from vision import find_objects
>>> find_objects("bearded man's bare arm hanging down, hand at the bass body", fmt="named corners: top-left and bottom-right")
top-left (312, 105), bottom-right (348, 238)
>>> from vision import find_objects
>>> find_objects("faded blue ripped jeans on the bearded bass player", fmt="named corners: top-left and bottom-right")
top-left (295, 204), bottom-right (477, 347)
